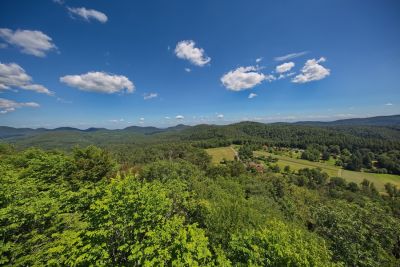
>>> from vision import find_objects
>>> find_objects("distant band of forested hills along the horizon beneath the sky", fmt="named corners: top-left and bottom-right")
top-left (0, 116), bottom-right (400, 153)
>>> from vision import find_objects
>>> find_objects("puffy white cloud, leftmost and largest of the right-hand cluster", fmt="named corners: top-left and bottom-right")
top-left (221, 66), bottom-right (275, 91)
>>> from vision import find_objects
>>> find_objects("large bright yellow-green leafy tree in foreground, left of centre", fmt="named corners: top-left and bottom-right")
top-left (66, 177), bottom-right (216, 266)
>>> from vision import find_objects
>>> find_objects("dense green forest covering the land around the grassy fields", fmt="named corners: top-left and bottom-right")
top-left (0, 115), bottom-right (400, 266)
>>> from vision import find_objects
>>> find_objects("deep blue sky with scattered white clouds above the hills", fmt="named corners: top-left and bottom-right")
top-left (0, 0), bottom-right (400, 128)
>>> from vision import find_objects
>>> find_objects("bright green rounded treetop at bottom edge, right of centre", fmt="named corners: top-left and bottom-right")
top-left (229, 220), bottom-right (339, 266)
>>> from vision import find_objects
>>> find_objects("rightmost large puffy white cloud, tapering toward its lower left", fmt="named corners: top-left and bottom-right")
top-left (292, 57), bottom-right (330, 83)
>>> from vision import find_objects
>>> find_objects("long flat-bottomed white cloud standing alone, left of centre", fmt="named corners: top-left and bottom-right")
top-left (60, 72), bottom-right (135, 94)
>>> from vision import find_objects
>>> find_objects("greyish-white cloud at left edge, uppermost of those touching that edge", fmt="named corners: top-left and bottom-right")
top-left (0, 28), bottom-right (57, 57)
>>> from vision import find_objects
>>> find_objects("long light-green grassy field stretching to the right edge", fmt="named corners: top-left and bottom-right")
top-left (254, 151), bottom-right (400, 192)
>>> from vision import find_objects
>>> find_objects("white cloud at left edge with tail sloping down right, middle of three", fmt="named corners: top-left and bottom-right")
top-left (0, 63), bottom-right (54, 95)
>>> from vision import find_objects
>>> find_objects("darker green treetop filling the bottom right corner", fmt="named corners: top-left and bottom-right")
top-left (313, 200), bottom-right (400, 266)
